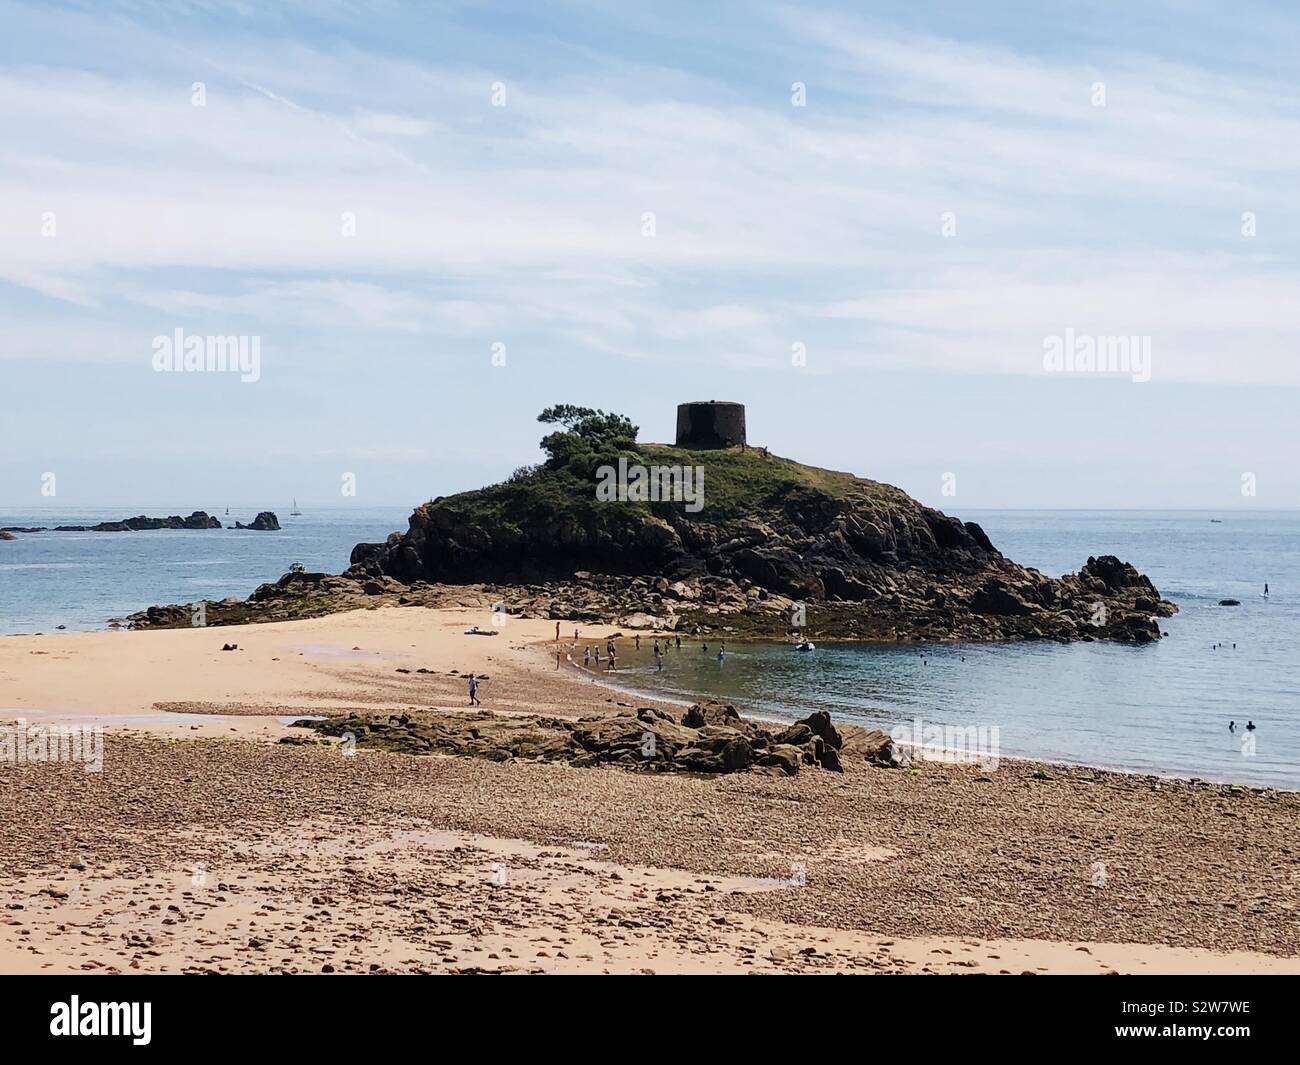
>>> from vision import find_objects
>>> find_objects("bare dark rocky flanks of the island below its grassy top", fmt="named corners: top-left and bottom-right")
top-left (347, 449), bottom-right (1177, 642)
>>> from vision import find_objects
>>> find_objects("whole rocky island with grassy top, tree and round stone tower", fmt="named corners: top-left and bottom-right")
top-left (130, 403), bottom-right (1177, 642)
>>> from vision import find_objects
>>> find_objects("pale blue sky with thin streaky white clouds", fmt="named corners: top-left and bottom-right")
top-left (0, 0), bottom-right (1300, 512)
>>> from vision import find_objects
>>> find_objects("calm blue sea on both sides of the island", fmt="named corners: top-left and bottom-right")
top-left (0, 506), bottom-right (1300, 789)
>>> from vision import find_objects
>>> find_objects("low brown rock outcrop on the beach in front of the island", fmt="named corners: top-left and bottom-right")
top-left (299, 702), bottom-right (870, 776)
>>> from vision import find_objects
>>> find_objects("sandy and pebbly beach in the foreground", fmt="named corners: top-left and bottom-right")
top-left (0, 607), bottom-right (1300, 973)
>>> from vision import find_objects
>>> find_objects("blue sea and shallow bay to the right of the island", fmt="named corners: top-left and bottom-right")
top-left (603, 511), bottom-right (1300, 789)
